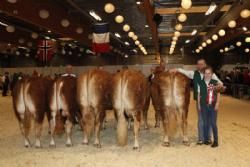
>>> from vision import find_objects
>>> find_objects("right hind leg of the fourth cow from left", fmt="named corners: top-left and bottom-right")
top-left (133, 111), bottom-right (141, 150)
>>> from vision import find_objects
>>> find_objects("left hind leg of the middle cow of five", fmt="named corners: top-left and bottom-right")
top-left (82, 107), bottom-right (95, 144)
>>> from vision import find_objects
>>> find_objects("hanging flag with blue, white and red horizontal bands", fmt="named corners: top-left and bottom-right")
top-left (92, 23), bottom-right (110, 53)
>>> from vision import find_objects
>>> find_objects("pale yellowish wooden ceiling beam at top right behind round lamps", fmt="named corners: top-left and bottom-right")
top-left (155, 5), bottom-right (231, 15)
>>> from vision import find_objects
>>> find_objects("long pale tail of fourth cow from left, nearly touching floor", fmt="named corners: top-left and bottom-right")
top-left (117, 72), bottom-right (128, 146)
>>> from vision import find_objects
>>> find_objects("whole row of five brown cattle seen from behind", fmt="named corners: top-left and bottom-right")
top-left (13, 69), bottom-right (190, 149)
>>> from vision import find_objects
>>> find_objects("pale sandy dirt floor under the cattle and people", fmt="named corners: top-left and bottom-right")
top-left (0, 93), bottom-right (250, 167)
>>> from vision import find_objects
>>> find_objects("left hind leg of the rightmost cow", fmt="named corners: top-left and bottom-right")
top-left (162, 110), bottom-right (170, 147)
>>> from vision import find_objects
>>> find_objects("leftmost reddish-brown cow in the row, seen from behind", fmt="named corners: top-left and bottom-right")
top-left (12, 76), bottom-right (52, 148)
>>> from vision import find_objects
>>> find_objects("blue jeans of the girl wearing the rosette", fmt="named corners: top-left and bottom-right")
top-left (201, 105), bottom-right (218, 143)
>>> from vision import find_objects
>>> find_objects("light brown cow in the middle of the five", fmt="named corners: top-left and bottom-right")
top-left (77, 69), bottom-right (112, 148)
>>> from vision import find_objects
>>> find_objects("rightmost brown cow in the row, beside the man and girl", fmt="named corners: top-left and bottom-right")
top-left (153, 72), bottom-right (190, 146)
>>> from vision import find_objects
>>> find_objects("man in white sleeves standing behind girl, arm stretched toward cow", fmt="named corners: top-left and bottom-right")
top-left (170, 58), bottom-right (223, 145)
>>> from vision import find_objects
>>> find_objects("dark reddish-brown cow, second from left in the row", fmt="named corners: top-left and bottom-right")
top-left (49, 75), bottom-right (79, 147)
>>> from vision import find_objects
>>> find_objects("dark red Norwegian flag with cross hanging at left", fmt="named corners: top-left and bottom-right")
top-left (37, 39), bottom-right (54, 62)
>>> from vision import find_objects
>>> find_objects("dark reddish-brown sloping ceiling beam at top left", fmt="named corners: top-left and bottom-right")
top-left (0, 0), bottom-right (91, 45)
